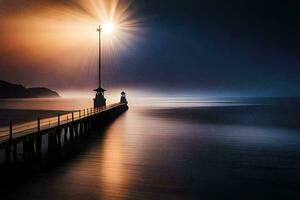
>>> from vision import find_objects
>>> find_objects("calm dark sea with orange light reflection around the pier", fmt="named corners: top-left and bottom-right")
top-left (1, 99), bottom-right (300, 200)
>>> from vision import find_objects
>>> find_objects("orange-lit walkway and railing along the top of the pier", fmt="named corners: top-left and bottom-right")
top-left (0, 103), bottom-right (121, 144)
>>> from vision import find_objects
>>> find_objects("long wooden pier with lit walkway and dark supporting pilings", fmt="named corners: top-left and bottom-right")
top-left (0, 103), bottom-right (128, 163)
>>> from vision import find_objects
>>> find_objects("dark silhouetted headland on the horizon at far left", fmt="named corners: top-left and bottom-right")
top-left (0, 80), bottom-right (60, 98)
